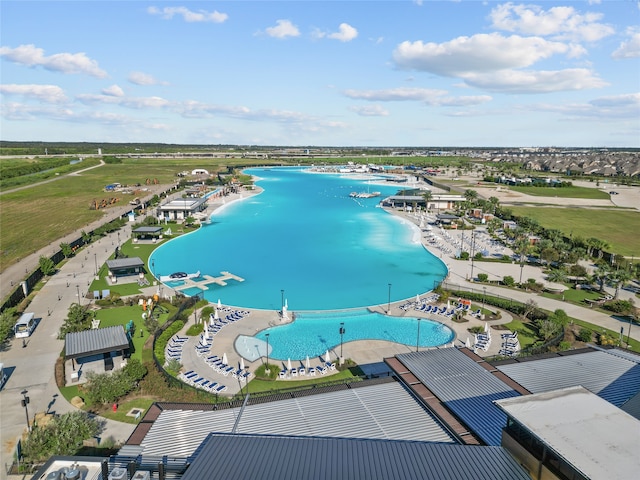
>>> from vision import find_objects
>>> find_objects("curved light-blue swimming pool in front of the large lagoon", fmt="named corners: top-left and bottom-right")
top-left (248, 309), bottom-right (455, 360)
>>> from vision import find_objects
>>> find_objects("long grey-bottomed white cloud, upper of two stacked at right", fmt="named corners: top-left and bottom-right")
top-left (393, 33), bottom-right (576, 76)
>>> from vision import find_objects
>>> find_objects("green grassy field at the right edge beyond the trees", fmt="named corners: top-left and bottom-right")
top-left (509, 207), bottom-right (640, 257)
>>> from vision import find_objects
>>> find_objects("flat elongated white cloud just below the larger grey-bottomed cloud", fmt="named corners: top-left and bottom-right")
top-left (464, 68), bottom-right (608, 93)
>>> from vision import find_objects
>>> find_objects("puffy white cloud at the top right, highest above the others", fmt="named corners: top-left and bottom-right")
top-left (489, 3), bottom-right (615, 42)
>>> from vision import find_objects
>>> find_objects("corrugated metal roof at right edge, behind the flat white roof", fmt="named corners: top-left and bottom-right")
top-left (497, 350), bottom-right (640, 407)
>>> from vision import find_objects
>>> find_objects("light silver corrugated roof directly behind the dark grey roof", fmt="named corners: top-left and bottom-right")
top-left (140, 382), bottom-right (454, 456)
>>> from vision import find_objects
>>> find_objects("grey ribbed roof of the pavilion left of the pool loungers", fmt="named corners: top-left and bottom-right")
top-left (64, 325), bottom-right (129, 358)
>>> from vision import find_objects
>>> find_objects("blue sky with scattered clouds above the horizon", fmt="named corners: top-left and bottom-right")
top-left (0, 0), bottom-right (640, 147)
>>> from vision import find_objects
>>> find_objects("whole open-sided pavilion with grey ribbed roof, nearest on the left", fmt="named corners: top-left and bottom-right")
top-left (64, 325), bottom-right (130, 383)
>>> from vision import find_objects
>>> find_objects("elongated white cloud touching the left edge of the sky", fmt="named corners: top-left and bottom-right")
top-left (0, 45), bottom-right (107, 78)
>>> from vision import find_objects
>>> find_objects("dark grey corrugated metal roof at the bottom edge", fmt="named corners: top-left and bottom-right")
top-left (182, 434), bottom-right (529, 480)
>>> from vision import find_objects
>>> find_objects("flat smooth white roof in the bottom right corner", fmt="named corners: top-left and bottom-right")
top-left (496, 386), bottom-right (640, 479)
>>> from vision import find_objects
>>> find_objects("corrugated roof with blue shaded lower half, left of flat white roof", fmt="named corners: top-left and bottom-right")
top-left (396, 348), bottom-right (520, 445)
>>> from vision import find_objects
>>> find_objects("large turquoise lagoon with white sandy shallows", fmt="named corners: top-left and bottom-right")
top-left (150, 168), bottom-right (447, 312)
